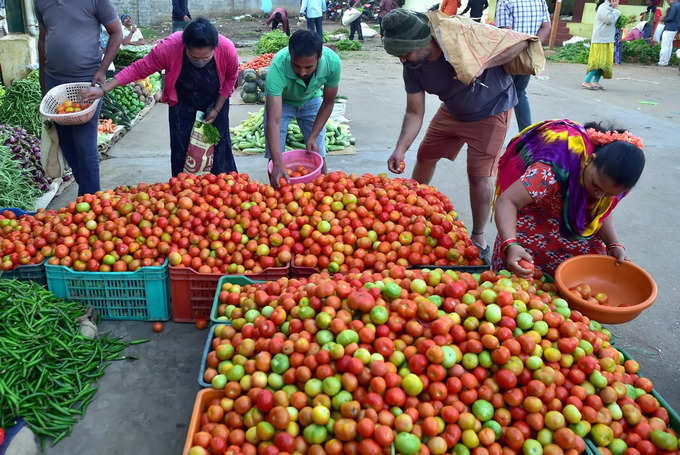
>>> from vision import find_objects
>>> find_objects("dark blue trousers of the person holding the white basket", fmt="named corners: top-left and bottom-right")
top-left (45, 74), bottom-right (102, 196)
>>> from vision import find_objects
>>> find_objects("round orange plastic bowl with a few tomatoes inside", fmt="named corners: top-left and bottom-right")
top-left (555, 254), bottom-right (657, 324)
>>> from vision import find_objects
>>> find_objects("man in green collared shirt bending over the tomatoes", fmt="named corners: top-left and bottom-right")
top-left (264, 30), bottom-right (342, 187)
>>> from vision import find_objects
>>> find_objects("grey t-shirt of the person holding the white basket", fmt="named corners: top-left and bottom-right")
top-left (34, 0), bottom-right (118, 82)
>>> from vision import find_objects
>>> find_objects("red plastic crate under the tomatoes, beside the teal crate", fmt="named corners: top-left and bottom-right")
top-left (170, 265), bottom-right (290, 322)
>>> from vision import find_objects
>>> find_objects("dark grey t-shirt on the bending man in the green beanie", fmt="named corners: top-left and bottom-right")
top-left (404, 54), bottom-right (517, 122)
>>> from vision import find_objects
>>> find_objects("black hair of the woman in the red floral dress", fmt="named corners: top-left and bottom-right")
top-left (583, 122), bottom-right (645, 189)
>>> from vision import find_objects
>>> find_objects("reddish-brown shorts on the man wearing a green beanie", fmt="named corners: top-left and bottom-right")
top-left (418, 104), bottom-right (512, 177)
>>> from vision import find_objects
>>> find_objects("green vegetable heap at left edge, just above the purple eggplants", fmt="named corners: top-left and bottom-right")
top-left (0, 70), bottom-right (43, 136)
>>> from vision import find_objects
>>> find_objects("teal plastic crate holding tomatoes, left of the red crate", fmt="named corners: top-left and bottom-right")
top-left (45, 259), bottom-right (170, 321)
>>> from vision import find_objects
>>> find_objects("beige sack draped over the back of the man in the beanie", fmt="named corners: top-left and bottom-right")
top-left (427, 11), bottom-right (545, 85)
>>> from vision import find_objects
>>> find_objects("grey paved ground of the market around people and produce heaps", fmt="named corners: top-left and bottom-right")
top-left (47, 41), bottom-right (680, 455)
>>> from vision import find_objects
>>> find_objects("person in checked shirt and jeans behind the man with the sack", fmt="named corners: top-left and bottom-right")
top-left (494, 0), bottom-right (550, 131)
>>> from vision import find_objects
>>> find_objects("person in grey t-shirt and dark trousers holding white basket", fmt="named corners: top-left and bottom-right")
top-left (35, 0), bottom-right (123, 195)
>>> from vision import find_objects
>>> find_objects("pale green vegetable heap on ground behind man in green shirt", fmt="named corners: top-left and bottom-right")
top-left (230, 108), bottom-right (356, 154)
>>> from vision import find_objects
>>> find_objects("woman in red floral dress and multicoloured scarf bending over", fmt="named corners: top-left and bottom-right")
top-left (492, 120), bottom-right (645, 276)
